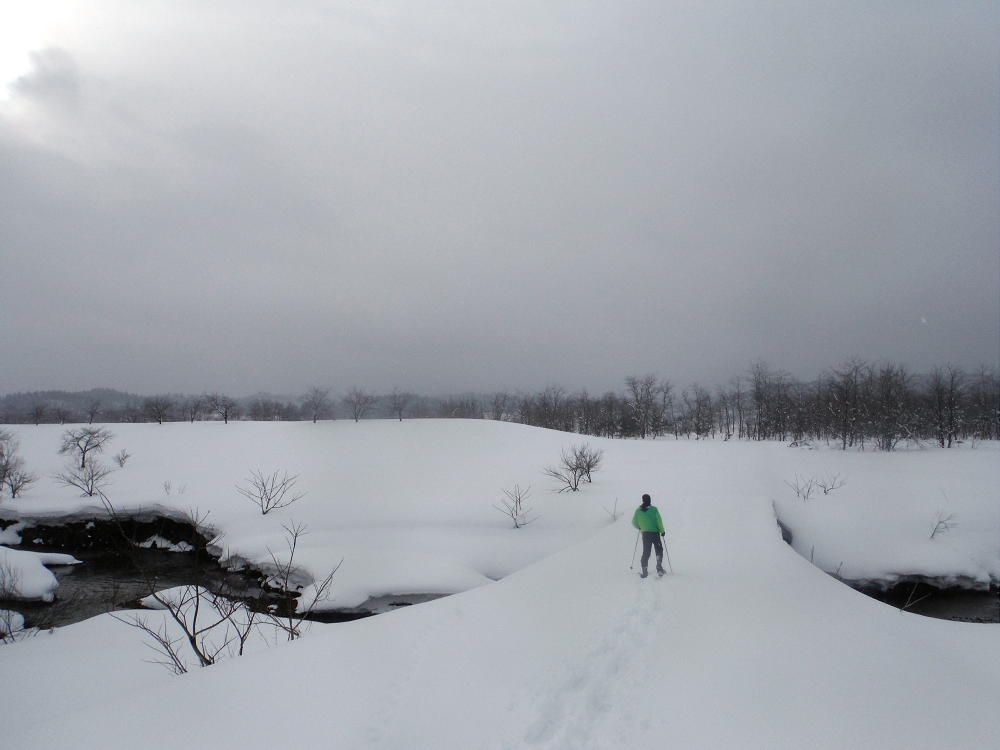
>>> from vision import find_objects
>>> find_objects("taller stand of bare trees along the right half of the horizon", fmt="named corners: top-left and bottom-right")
top-left (490, 360), bottom-right (1000, 451)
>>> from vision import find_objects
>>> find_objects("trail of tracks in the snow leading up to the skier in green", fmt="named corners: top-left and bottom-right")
top-left (506, 574), bottom-right (667, 750)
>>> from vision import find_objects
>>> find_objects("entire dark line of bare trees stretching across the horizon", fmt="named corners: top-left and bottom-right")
top-left (0, 360), bottom-right (1000, 450)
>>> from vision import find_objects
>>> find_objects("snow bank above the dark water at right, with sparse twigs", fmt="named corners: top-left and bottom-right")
top-left (772, 443), bottom-right (1000, 589)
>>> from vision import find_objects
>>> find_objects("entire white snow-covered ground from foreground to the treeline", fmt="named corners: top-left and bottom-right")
top-left (0, 421), bottom-right (1000, 750)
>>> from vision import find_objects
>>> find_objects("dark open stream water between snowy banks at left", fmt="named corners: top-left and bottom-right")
top-left (9, 548), bottom-right (262, 628)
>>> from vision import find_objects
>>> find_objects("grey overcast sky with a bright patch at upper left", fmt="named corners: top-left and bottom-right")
top-left (0, 0), bottom-right (1000, 395)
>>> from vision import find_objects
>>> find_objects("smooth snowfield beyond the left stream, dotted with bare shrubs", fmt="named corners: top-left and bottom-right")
top-left (0, 420), bottom-right (614, 608)
